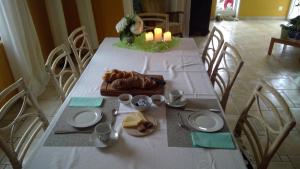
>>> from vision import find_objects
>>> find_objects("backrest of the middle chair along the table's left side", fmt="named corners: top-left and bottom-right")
top-left (45, 45), bottom-right (79, 100)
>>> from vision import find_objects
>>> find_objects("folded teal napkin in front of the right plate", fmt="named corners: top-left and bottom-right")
top-left (191, 132), bottom-right (235, 149)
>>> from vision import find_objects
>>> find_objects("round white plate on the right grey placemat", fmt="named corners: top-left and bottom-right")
top-left (187, 110), bottom-right (224, 132)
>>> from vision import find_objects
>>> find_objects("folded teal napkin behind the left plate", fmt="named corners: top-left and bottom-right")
top-left (69, 97), bottom-right (103, 107)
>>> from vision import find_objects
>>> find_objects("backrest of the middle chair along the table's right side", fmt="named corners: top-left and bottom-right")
top-left (211, 42), bottom-right (244, 110)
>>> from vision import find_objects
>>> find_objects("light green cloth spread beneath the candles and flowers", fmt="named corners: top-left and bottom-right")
top-left (114, 33), bottom-right (180, 52)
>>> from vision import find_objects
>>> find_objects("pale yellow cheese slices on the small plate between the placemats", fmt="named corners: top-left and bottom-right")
top-left (123, 112), bottom-right (147, 128)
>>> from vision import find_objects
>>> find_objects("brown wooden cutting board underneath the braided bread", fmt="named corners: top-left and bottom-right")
top-left (100, 75), bottom-right (164, 96)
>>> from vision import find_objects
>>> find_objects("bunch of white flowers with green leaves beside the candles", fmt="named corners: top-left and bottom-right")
top-left (116, 15), bottom-right (144, 43)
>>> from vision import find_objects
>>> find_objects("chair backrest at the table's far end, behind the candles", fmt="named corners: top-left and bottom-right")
top-left (138, 13), bottom-right (169, 31)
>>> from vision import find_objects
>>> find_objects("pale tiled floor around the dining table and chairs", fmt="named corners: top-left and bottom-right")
top-left (0, 20), bottom-right (300, 169)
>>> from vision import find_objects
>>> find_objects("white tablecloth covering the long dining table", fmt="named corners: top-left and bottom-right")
top-left (24, 37), bottom-right (246, 169)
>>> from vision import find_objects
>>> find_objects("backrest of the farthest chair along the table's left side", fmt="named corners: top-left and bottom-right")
top-left (68, 26), bottom-right (94, 74)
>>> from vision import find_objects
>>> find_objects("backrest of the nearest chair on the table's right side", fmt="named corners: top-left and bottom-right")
top-left (234, 81), bottom-right (296, 169)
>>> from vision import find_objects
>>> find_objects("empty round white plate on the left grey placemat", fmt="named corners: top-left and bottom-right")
top-left (67, 110), bottom-right (103, 128)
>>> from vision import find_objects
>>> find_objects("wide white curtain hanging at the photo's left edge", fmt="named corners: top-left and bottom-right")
top-left (0, 0), bottom-right (49, 96)
